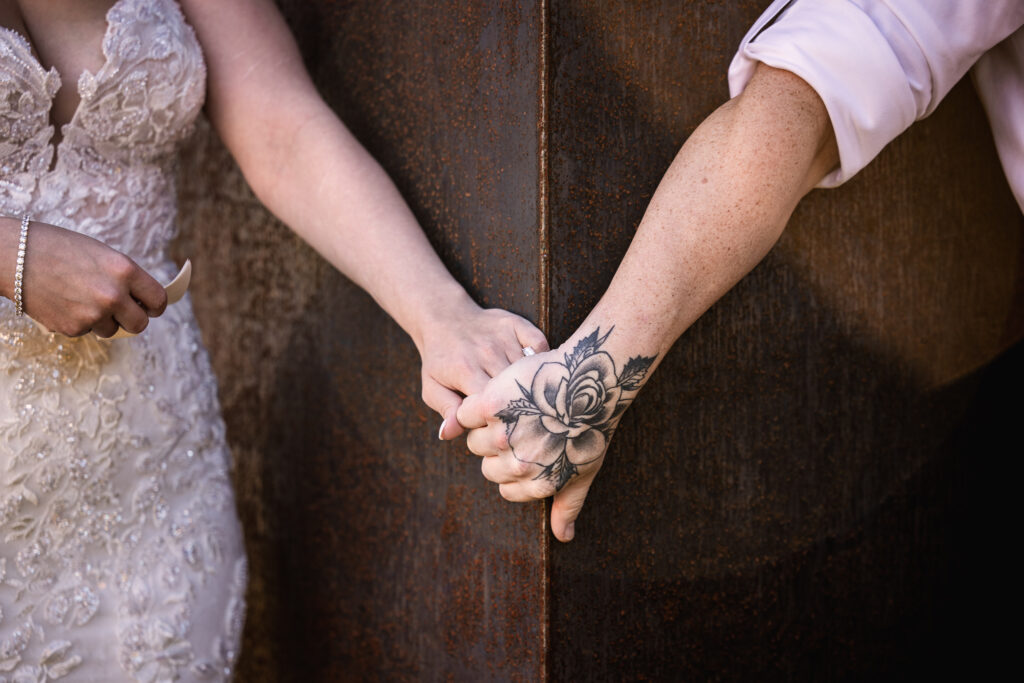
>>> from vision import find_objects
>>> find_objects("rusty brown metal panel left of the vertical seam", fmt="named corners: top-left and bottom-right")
top-left (178, 0), bottom-right (545, 682)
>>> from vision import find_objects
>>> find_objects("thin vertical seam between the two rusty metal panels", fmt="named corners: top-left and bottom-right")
top-left (537, 0), bottom-right (551, 682)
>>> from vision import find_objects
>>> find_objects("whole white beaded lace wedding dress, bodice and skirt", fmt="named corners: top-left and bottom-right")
top-left (0, 0), bottom-right (246, 683)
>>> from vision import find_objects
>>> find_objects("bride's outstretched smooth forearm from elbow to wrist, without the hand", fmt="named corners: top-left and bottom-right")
top-left (234, 102), bottom-right (475, 350)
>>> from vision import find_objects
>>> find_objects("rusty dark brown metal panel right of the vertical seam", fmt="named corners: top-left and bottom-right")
top-left (549, 0), bottom-right (1024, 681)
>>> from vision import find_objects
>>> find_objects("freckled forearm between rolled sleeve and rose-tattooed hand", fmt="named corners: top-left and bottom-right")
top-left (566, 68), bottom-right (838, 378)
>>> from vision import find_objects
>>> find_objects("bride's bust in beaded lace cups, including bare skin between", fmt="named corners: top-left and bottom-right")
top-left (0, 0), bottom-right (206, 176)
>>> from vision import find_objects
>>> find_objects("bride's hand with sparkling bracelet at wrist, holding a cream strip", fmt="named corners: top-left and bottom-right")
top-left (0, 218), bottom-right (167, 337)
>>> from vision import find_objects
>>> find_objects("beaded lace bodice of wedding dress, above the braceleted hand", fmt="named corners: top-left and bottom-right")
top-left (0, 0), bottom-right (206, 267)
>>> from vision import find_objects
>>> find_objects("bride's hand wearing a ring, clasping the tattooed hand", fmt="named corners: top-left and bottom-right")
top-left (419, 297), bottom-right (548, 439)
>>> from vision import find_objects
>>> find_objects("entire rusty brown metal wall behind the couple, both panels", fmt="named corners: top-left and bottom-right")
top-left (172, 0), bottom-right (1024, 681)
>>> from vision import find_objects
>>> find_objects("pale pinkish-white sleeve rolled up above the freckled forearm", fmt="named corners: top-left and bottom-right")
top-left (729, 0), bottom-right (1024, 187)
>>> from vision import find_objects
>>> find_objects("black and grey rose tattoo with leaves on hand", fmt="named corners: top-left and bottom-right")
top-left (498, 327), bottom-right (657, 490)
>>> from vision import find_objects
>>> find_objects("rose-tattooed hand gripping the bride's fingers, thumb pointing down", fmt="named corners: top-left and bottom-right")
top-left (458, 330), bottom-right (654, 541)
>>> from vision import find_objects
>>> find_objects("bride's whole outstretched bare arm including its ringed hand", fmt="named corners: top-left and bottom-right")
top-left (181, 0), bottom-right (547, 438)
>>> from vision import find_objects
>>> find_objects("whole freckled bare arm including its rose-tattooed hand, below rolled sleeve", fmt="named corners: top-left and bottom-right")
top-left (459, 65), bottom-right (839, 541)
